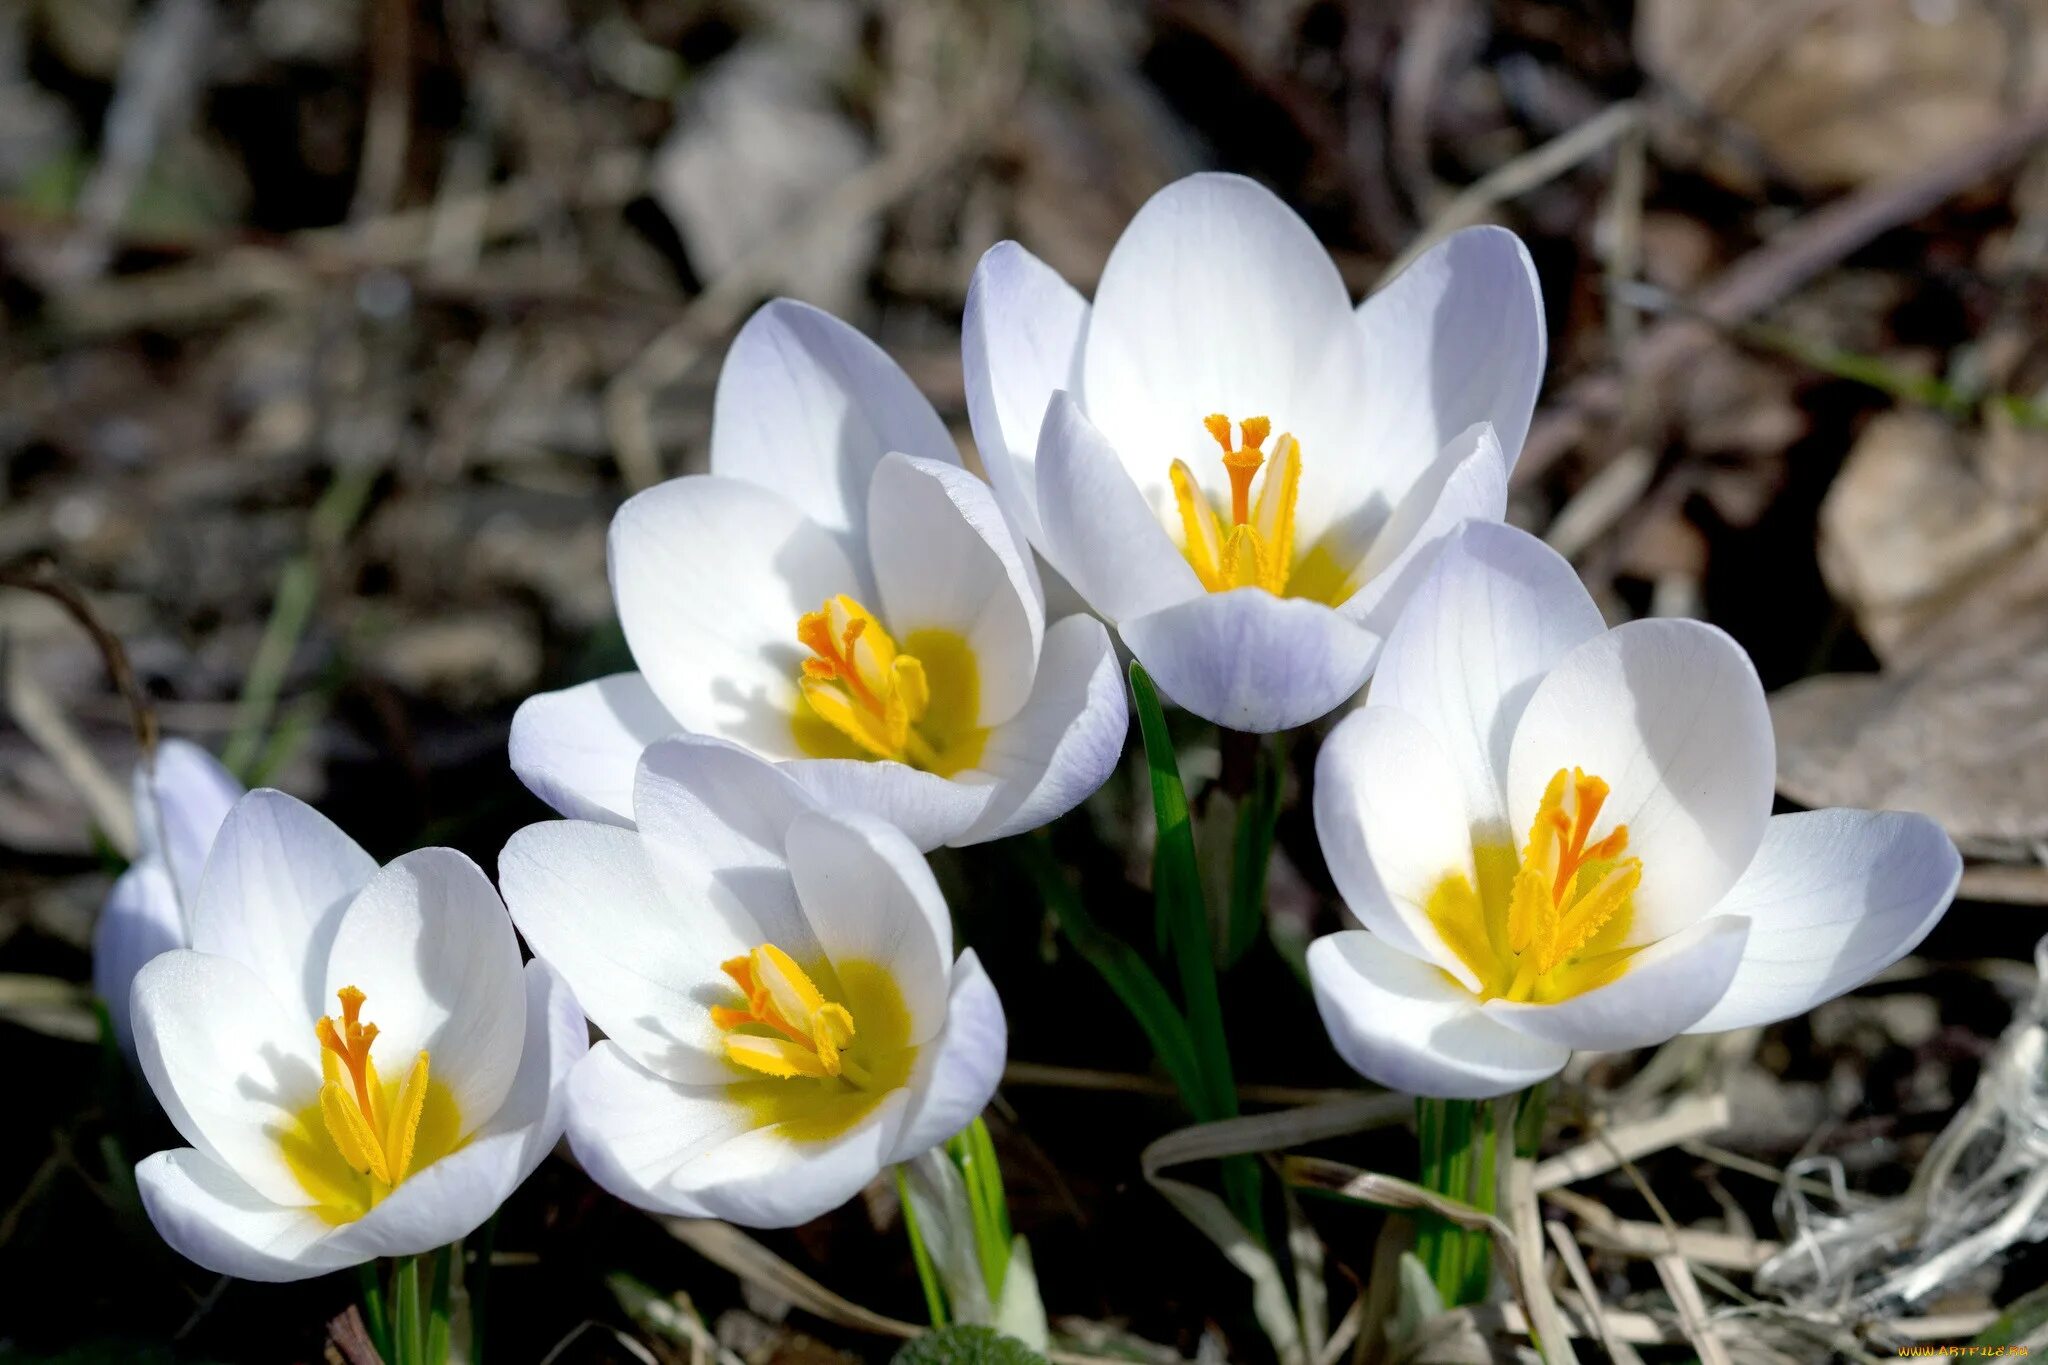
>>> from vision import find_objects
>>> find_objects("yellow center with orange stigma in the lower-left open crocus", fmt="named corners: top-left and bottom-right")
top-left (279, 986), bottom-right (461, 1224)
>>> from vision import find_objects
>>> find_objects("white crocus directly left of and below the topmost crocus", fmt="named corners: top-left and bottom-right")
top-left (512, 301), bottom-right (1126, 849)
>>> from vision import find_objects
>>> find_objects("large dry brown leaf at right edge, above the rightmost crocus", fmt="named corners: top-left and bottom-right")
top-left (1772, 413), bottom-right (2048, 855)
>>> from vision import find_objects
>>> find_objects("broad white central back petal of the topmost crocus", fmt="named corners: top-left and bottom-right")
top-left (1081, 174), bottom-right (1366, 511)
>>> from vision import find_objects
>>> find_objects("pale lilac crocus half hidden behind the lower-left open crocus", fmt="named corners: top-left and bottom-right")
top-left (92, 739), bottom-right (242, 1056)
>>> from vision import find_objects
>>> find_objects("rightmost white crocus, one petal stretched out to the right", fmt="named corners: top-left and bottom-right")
top-left (1309, 524), bottom-right (1962, 1099)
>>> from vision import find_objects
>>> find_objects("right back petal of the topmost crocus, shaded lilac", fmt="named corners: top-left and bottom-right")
top-left (1346, 227), bottom-right (1546, 503)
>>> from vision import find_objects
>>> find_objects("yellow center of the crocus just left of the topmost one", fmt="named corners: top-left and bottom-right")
top-left (797, 593), bottom-right (987, 778)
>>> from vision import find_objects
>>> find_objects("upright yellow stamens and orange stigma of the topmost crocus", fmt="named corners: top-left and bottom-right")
top-left (1171, 413), bottom-right (1300, 598)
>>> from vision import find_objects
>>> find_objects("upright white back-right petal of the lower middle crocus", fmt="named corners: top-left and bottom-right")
top-left (788, 814), bottom-right (952, 1044)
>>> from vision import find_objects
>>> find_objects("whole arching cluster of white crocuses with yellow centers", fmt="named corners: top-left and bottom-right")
top-left (98, 165), bottom-right (1958, 1312)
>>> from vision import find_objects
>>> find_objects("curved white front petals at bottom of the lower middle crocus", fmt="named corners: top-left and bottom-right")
top-left (569, 1044), bottom-right (907, 1228)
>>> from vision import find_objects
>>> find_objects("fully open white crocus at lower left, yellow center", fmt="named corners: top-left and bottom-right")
top-left (131, 790), bottom-right (588, 1281)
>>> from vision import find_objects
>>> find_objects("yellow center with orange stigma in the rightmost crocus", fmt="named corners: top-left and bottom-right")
top-left (1425, 767), bottom-right (1642, 1003)
